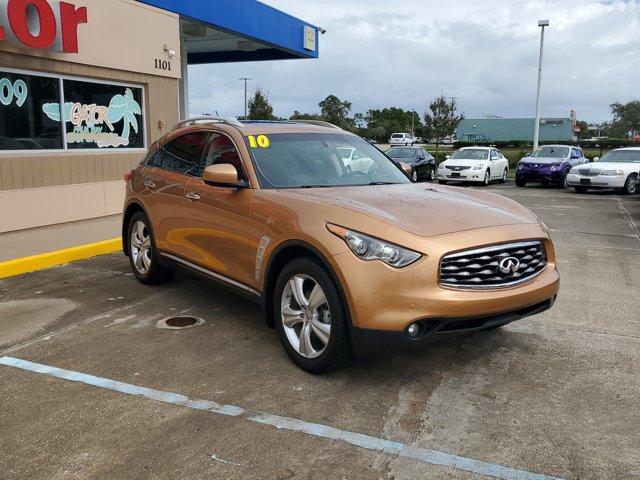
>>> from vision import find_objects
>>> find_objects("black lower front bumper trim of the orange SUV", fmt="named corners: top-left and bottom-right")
top-left (351, 296), bottom-right (556, 355)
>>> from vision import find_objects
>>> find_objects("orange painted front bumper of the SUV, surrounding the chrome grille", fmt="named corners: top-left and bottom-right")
top-left (329, 224), bottom-right (560, 340)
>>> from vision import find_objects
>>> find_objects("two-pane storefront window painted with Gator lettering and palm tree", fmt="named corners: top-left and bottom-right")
top-left (0, 70), bottom-right (146, 151)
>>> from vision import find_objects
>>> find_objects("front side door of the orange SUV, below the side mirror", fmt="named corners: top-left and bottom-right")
top-left (184, 132), bottom-right (256, 286)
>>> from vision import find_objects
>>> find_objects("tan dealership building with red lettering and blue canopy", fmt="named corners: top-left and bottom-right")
top-left (0, 0), bottom-right (318, 233)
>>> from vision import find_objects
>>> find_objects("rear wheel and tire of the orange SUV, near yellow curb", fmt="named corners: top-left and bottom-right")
top-left (126, 211), bottom-right (174, 285)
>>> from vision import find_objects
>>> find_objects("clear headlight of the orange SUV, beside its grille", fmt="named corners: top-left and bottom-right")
top-left (327, 224), bottom-right (422, 268)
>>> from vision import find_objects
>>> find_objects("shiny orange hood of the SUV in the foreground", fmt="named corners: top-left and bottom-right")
top-left (280, 184), bottom-right (538, 237)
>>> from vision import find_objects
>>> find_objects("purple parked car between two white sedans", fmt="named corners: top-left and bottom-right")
top-left (516, 145), bottom-right (589, 187)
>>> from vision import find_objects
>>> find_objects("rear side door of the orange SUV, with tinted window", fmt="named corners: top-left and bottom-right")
top-left (140, 132), bottom-right (207, 254)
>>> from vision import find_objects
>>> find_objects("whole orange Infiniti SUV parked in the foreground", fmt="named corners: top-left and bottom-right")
top-left (123, 118), bottom-right (559, 373)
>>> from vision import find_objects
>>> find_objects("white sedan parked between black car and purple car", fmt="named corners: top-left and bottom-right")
top-left (438, 147), bottom-right (509, 185)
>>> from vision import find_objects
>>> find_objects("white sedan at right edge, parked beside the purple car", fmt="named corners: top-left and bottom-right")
top-left (567, 147), bottom-right (640, 195)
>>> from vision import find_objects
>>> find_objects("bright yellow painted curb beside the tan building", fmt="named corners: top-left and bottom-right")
top-left (0, 238), bottom-right (122, 278)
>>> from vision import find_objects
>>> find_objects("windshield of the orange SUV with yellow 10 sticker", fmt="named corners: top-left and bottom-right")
top-left (245, 133), bottom-right (411, 188)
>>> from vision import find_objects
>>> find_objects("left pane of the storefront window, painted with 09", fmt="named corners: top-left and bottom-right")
top-left (0, 71), bottom-right (63, 150)
